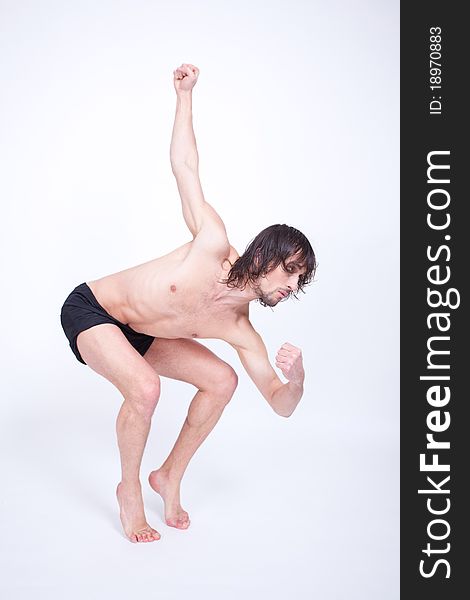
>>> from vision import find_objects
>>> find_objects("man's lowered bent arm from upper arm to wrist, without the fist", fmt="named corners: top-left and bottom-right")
top-left (229, 322), bottom-right (303, 417)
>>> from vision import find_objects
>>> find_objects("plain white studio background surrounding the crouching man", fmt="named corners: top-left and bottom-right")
top-left (0, 0), bottom-right (399, 600)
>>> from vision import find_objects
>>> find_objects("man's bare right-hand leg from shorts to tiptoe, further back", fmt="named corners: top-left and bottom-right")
top-left (144, 338), bottom-right (237, 529)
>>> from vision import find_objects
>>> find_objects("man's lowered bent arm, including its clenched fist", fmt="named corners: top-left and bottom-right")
top-left (226, 319), bottom-right (305, 417)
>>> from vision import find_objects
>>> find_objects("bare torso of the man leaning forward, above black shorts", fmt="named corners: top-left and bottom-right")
top-left (87, 242), bottom-right (248, 339)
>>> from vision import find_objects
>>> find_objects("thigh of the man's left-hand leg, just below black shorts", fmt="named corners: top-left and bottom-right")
top-left (77, 323), bottom-right (158, 398)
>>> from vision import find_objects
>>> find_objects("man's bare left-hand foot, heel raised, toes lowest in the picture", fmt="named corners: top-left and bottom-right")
top-left (116, 483), bottom-right (160, 543)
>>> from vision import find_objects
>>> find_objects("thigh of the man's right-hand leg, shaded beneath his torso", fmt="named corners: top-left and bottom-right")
top-left (144, 338), bottom-right (236, 390)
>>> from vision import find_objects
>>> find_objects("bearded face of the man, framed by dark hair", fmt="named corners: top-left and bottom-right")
top-left (253, 256), bottom-right (306, 306)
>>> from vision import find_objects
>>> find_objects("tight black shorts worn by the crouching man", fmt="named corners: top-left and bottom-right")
top-left (60, 283), bottom-right (155, 365)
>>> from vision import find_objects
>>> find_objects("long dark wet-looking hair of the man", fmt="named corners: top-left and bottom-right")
top-left (224, 225), bottom-right (317, 296)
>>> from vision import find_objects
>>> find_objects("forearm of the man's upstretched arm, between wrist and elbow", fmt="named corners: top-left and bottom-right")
top-left (170, 91), bottom-right (199, 175)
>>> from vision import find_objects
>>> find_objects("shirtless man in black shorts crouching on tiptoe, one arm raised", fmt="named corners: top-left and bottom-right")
top-left (61, 64), bottom-right (316, 542)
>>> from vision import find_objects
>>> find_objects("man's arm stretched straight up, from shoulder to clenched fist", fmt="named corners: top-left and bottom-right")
top-left (170, 64), bottom-right (228, 252)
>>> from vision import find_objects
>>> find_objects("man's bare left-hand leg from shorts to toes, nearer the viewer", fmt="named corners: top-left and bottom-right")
top-left (77, 323), bottom-right (160, 542)
